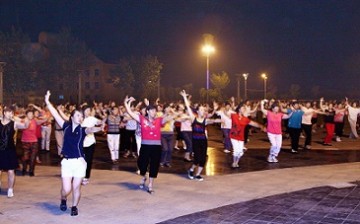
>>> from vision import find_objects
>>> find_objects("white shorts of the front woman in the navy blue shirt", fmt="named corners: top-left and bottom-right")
top-left (61, 157), bottom-right (87, 178)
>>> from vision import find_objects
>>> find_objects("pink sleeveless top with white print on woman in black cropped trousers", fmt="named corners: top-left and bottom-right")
top-left (140, 115), bottom-right (162, 145)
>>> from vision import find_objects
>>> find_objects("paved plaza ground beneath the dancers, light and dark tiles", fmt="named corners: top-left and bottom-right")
top-left (0, 129), bottom-right (360, 224)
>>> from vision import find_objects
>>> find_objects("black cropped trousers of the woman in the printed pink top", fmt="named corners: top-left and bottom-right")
top-left (137, 145), bottom-right (161, 178)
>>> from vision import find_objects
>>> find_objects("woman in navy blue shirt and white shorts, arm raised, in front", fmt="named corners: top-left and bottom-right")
top-left (45, 91), bottom-right (103, 216)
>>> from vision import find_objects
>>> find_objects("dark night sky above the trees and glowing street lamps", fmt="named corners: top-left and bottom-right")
top-left (0, 0), bottom-right (360, 97)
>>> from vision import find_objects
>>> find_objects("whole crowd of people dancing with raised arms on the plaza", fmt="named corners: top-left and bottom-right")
top-left (0, 91), bottom-right (360, 216)
